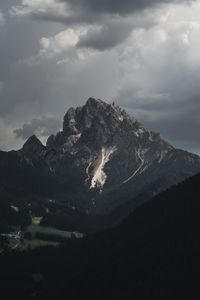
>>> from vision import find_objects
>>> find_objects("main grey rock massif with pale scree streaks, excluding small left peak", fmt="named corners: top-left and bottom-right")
top-left (39, 98), bottom-right (173, 191)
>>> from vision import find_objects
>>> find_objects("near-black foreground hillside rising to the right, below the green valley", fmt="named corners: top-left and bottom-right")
top-left (0, 171), bottom-right (200, 300)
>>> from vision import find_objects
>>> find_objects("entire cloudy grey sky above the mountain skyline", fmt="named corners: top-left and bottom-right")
top-left (0, 0), bottom-right (200, 154)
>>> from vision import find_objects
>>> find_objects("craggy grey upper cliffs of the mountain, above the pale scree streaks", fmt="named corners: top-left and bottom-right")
top-left (47, 98), bottom-right (173, 157)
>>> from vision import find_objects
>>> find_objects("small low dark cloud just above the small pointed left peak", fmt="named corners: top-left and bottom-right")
top-left (13, 117), bottom-right (61, 140)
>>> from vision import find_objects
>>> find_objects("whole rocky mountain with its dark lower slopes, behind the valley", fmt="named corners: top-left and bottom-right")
top-left (0, 98), bottom-right (200, 230)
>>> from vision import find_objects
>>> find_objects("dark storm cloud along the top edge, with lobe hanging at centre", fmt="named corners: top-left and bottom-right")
top-left (12, 0), bottom-right (195, 51)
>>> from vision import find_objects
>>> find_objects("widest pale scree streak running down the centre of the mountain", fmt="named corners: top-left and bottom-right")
top-left (90, 147), bottom-right (117, 190)
